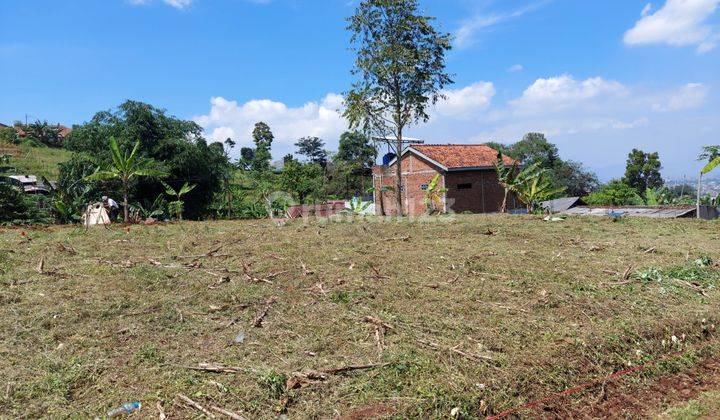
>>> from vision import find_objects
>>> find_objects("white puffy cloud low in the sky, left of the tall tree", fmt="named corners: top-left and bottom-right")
top-left (194, 93), bottom-right (347, 156)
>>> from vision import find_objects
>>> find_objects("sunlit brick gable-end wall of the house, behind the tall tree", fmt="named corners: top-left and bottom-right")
top-left (373, 154), bottom-right (444, 216)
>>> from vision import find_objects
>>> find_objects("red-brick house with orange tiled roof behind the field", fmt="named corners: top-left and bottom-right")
top-left (373, 144), bottom-right (517, 216)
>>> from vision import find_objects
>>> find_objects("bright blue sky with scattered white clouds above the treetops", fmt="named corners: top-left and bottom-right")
top-left (0, 0), bottom-right (720, 179)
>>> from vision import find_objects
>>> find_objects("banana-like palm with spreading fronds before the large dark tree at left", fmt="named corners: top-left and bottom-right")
top-left (85, 137), bottom-right (167, 223)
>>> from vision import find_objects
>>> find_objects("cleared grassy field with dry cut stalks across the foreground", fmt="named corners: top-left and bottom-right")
top-left (0, 215), bottom-right (720, 418)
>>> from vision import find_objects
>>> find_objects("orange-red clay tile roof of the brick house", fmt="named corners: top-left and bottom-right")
top-left (410, 144), bottom-right (515, 169)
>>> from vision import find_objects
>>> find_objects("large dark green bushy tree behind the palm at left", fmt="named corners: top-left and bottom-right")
top-left (60, 101), bottom-right (231, 219)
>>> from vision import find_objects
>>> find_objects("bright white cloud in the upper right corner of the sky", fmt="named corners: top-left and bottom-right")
top-left (623, 0), bottom-right (720, 53)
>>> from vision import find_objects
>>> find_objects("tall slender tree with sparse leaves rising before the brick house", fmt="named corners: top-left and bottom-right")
top-left (344, 0), bottom-right (452, 216)
